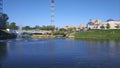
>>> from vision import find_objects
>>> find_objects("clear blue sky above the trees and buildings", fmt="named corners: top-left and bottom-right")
top-left (3, 0), bottom-right (120, 27)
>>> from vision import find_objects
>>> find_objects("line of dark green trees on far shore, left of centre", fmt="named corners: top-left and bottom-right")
top-left (0, 13), bottom-right (58, 30)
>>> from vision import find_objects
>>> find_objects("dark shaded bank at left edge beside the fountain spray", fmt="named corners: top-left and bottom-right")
top-left (0, 30), bottom-right (17, 40)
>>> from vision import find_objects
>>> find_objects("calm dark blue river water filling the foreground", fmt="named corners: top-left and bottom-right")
top-left (0, 38), bottom-right (120, 68)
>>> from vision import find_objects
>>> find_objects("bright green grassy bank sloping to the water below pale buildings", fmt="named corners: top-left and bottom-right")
top-left (75, 30), bottom-right (120, 39)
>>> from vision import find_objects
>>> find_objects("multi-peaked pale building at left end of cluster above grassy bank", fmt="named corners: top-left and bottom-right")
top-left (87, 19), bottom-right (102, 29)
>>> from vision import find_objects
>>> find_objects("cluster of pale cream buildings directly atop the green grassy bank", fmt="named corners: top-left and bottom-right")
top-left (87, 19), bottom-right (120, 29)
